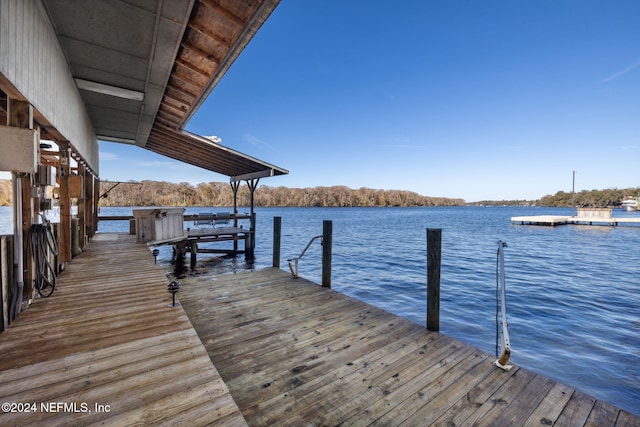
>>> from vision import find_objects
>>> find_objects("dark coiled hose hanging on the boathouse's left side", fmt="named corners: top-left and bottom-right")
top-left (30, 216), bottom-right (58, 297)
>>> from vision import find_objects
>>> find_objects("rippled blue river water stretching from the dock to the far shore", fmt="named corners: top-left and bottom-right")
top-left (0, 207), bottom-right (640, 414)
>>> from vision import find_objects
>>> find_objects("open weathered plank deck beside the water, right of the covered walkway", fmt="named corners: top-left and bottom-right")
top-left (180, 269), bottom-right (640, 426)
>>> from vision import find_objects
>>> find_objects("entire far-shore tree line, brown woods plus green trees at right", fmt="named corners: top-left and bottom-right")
top-left (0, 180), bottom-right (640, 207)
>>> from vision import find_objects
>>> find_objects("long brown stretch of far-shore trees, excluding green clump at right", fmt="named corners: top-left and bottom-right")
top-left (100, 181), bottom-right (464, 207)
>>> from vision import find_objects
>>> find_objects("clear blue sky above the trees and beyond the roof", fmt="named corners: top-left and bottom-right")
top-left (100, 0), bottom-right (640, 201)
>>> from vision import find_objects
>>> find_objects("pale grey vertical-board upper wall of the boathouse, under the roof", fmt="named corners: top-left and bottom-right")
top-left (0, 0), bottom-right (99, 174)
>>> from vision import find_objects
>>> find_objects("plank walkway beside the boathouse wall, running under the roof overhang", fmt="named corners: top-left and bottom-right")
top-left (0, 234), bottom-right (246, 426)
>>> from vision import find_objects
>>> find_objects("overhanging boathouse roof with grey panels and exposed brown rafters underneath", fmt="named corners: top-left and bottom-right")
top-left (43, 0), bottom-right (288, 180)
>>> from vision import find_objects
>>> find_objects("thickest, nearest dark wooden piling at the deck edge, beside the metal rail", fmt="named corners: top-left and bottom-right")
top-left (427, 228), bottom-right (442, 332)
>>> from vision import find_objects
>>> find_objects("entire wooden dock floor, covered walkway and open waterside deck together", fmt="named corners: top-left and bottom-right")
top-left (0, 234), bottom-right (640, 426)
